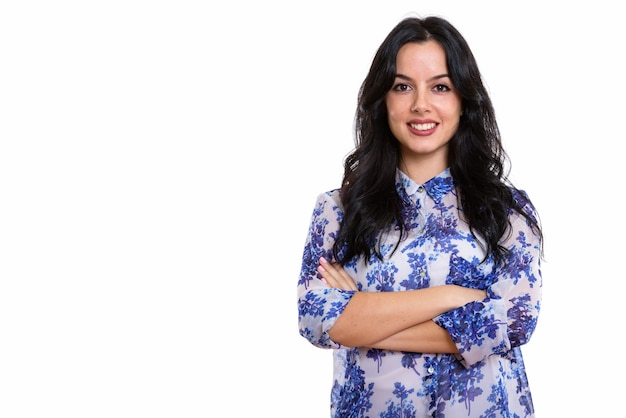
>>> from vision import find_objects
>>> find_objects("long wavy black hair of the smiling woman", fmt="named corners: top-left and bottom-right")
top-left (333, 16), bottom-right (543, 265)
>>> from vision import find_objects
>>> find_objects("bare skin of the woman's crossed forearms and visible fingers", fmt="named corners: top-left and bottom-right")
top-left (318, 258), bottom-right (486, 352)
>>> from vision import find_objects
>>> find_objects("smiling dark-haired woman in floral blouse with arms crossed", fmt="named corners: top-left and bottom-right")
top-left (298, 17), bottom-right (542, 418)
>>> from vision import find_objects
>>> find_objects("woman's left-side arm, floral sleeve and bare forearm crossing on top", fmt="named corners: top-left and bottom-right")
top-left (297, 192), bottom-right (485, 352)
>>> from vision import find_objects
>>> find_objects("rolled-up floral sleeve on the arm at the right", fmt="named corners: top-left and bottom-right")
top-left (434, 194), bottom-right (542, 367)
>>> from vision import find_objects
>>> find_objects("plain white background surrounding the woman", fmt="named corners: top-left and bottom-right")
top-left (0, 0), bottom-right (626, 418)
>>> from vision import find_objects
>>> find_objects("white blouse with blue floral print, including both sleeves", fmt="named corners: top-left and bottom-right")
top-left (297, 170), bottom-right (542, 418)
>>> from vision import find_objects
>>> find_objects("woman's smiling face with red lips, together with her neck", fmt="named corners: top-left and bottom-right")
top-left (385, 41), bottom-right (461, 183)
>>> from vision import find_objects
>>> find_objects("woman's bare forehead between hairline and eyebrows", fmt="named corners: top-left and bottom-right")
top-left (396, 40), bottom-right (448, 75)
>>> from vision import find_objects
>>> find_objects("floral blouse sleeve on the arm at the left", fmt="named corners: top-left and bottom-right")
top-left (297, 191), bottom-right (354, 348)
